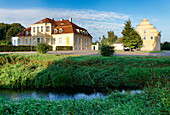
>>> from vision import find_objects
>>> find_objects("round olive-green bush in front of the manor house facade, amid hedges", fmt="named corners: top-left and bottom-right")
top-left (36, 43), bottom-right (50, 54)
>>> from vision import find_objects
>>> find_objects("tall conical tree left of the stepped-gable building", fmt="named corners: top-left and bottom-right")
top-left (120, 19), bottom-right (143, 49)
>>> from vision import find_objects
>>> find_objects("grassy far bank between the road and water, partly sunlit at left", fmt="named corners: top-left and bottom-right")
top-left (0, 54), bottom-right (170, 88)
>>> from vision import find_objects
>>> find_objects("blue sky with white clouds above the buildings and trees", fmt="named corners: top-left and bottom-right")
top-left (0, 0), bottom-right (170, 42)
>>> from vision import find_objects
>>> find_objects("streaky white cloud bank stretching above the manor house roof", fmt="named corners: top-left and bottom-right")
top-left (0, 9), bottom-right (130, 41)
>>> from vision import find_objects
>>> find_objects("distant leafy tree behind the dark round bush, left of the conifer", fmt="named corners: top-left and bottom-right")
top-left (101, 31), bottom-right (118, 45)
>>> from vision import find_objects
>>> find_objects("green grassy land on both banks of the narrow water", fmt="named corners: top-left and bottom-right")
top-left (0, 54), bottom-right (170, 115)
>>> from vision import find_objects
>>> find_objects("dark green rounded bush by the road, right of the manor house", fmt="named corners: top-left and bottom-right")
top-left (101, 45), bottom-right (115, 56)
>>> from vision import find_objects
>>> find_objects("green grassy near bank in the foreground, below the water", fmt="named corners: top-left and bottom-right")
top-left (0, 87), bottom-right (169, 115)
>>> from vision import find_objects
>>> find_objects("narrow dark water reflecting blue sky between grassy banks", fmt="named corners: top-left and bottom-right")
top-left (0, 87), bottom-right (142, 100)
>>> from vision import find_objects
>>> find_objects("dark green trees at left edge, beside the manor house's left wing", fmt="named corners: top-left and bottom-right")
top-left (0, 23), bottom-right (25, 42)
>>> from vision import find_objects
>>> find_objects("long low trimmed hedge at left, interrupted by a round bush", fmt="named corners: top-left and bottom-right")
top-left (0, 45), bottom-right (52, 52)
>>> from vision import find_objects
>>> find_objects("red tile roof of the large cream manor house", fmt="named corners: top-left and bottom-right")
top-left (17, 18), bottom-right (92, 37)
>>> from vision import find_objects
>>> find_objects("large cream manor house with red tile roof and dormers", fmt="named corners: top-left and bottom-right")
top-left (12, 18), bottom-right (92, 50)
